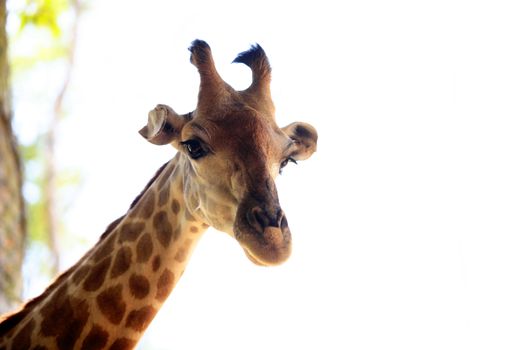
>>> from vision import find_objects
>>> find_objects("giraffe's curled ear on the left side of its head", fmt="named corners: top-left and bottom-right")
top-left (139, 105), bottom-right (191, 145)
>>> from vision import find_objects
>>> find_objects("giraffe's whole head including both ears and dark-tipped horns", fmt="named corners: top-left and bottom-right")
top-left (140, 40), bottom-right (317, 265)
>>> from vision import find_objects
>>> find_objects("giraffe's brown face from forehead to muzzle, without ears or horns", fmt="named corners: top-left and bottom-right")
top-left (180, 108), bottom-right (316, 265)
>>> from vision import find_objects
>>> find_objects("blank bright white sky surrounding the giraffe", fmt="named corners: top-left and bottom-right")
top-left (9, 0), bottom-right (525, 350)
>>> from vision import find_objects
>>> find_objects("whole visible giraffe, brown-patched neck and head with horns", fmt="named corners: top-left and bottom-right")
top-left (0, 40), bottom-right (317, 350)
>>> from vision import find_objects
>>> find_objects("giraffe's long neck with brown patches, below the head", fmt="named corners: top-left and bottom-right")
top-left (0, 155), bottom-right (208, 349)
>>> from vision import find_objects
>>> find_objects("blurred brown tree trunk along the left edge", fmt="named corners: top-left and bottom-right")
top-left (0, 0), bottom-right (25, 314)
